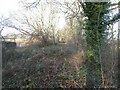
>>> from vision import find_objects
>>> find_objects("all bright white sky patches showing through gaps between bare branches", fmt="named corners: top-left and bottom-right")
top-left (0, 0), bottom-right (118, 35)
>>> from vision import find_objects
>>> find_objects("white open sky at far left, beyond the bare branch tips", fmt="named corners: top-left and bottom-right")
top-left (0, 0), bottom-right (20, 36)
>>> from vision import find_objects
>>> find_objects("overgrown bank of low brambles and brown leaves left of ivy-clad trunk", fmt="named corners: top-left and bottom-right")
top-left (3, 45), bottom-right (86, 88)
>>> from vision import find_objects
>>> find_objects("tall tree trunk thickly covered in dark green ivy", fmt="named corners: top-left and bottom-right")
top-left (83, 2), bottom-right (110, 87)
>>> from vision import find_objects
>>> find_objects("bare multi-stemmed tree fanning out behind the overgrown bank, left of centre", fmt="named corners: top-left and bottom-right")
top-left (8, 0), bottom-right (57, 44)
